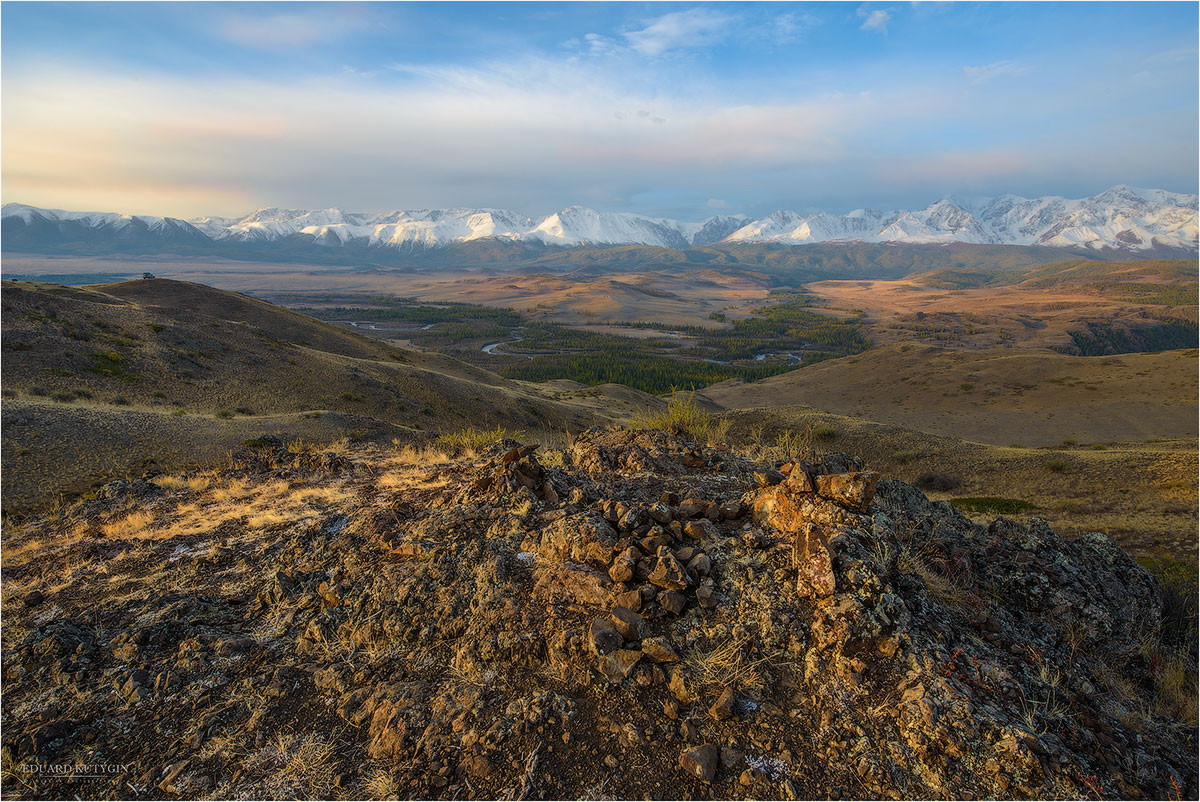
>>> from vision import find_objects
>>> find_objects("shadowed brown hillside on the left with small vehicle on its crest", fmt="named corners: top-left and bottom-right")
top-left (0, 279), bottom-right (660, 510)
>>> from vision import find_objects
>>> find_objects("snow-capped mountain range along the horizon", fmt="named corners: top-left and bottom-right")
top-left (0, 186), bottom-right (1198, 251)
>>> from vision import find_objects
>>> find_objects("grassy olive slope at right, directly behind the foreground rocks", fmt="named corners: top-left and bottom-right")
top-left (715, 396), bottom-right (1198, 561)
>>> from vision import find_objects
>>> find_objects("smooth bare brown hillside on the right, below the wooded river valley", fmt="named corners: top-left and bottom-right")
top-left (704, 345), bottom-right (1200, 445)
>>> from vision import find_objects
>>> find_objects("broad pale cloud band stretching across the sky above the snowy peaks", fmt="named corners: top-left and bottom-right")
top-left (2, 48), bottom-right (1196, 219)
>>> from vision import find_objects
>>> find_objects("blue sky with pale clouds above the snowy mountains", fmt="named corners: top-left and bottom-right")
top-left (0, 1), bottom-right (1200, 220)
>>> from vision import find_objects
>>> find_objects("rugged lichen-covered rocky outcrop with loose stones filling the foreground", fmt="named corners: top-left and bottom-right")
top-left (2, 429), bottom-right (1196, 798)
